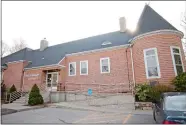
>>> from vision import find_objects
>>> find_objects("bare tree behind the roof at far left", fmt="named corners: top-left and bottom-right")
top-left (9, 38), bottom-right (27, 54)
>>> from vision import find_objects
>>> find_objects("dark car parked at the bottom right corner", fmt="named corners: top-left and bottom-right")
top-left (153, 92), bottom-right (186, 124)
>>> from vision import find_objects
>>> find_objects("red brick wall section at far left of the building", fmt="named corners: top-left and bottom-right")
top-left (3, 62), bottom-right (26, 90)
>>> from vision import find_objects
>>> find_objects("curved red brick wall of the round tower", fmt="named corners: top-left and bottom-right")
top-left (133, 34), bottom-right (186, 84)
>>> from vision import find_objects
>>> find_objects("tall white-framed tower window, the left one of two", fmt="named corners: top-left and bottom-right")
top-left (143, 48), bottom-right (161, 79)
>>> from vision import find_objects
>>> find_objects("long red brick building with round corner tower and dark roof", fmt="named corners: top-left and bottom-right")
top-left (2, 5), bottom-right (186, 92)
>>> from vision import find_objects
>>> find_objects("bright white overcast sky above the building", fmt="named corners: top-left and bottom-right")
top-left (2, 1), bottom-right (186, 49)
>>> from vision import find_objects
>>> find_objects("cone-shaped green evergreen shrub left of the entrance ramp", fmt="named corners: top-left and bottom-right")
top-left (28, 84), bottom-right (44, 105)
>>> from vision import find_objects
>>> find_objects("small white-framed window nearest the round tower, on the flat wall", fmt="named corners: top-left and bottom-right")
top-left (100, 57), bottom-right (110, 73)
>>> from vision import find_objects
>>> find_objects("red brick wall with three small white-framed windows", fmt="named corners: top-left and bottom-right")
top-left (61, 48), bottom-right (132, 91)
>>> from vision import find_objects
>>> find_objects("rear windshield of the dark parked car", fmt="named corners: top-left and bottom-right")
top-left (165, 94), bottom-right (186, 111)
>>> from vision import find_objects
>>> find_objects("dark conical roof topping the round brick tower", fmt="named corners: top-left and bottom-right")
top-left (135, 5), bottom-right (177, 35)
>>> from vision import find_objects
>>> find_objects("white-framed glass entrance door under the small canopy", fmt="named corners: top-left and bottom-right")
top-left (46, 72), bottom-right (58, 91)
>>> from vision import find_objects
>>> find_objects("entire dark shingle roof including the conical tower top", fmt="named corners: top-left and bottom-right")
top-left (2, 5), bottom-right (177, 68)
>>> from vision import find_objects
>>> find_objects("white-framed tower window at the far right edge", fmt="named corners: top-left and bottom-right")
top-left (170, 46), bottom-right (185, 76)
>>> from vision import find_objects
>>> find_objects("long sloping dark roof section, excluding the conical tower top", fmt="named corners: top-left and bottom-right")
top-left (2, 31), bottom-right (132, 68)
